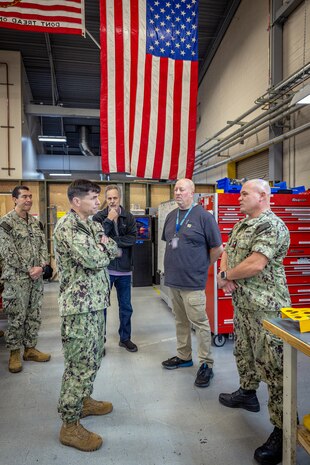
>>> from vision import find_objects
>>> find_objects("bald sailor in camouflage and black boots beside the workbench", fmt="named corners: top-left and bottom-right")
top-left (218, 179), bottom-right (291, 465)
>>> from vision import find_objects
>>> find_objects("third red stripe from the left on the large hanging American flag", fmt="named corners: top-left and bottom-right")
top-left (129, 0), bottom-right (139, 160)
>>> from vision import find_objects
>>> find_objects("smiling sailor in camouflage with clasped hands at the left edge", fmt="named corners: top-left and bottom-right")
top-left (0, 186), bottom-right (50, 373)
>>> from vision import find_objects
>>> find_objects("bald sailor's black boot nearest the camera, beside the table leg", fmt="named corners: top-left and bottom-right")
top-left (254, 426), bottom-right (283, 465)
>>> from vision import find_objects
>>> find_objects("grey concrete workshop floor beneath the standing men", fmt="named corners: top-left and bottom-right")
top-left (0, 283), bottom-right (310, 465)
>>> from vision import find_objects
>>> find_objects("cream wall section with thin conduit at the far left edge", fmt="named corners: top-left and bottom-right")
top-left (0, 50), bottom-right (22, 179)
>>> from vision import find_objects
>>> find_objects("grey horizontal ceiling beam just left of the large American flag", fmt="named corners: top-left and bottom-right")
top-left (25, 103), bottom-right (100, 118)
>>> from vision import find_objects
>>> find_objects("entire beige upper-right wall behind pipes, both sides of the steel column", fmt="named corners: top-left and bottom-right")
top-left (194, 0), bottom-right (310, 188)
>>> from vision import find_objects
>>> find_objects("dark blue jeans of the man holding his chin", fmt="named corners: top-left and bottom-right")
top-left (110, 275), bottom-right (133, 342)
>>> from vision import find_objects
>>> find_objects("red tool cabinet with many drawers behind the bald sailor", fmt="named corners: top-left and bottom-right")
top-left (201, 194), bottom-right (310, 347)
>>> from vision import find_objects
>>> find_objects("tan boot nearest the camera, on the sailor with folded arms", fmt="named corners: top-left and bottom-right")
top-left (59, 421), bottom-right (103, 452)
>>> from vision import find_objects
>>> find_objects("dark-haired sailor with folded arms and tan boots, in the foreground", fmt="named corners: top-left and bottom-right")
top-left (54, 179), bottom-right (118, 451)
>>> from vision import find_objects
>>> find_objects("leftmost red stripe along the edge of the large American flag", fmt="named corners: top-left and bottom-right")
top-left (100, 0), bottom-right (110, 173)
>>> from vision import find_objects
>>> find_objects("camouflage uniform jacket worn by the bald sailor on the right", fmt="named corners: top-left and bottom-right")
top-left (225, 210), bottom-right (291, 311)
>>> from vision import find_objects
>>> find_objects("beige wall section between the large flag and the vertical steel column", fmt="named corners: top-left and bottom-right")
top-left (195, 0), bottom-right (269, 183)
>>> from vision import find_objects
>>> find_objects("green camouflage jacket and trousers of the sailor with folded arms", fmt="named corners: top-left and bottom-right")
top-left (54, 211), bottom-right (118, 423)
